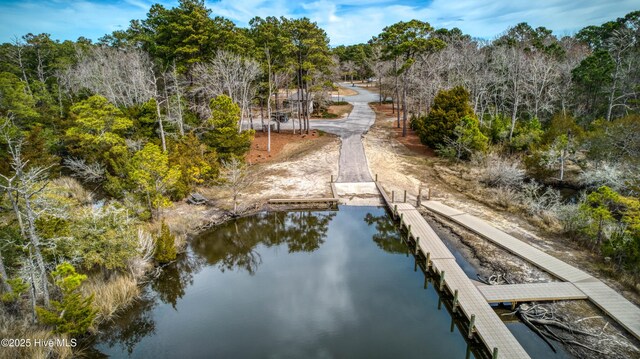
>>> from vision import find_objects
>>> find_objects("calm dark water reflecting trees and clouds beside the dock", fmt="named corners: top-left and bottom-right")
top-left (95, 207), bottom-right (476, 358)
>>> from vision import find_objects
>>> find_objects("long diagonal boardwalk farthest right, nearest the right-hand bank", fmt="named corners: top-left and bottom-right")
top-left (422, 201), bottom-right (640, 339)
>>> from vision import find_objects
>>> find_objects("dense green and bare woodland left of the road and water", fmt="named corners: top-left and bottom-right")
top-left (0, 0), bottom-right (333, 348)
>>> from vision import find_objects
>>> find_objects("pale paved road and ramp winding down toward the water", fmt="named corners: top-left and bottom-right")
top-left (310, 84), bottom-right (378, 182)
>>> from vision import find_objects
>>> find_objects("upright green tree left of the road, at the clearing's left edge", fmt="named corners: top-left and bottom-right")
top-left (202, 95), bottom-right (254, 161)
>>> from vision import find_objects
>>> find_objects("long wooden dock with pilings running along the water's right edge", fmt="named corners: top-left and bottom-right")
top-left (380, 204), bottom-right (529, 358)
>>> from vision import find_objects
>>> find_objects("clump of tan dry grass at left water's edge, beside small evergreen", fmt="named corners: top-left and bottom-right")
top-left (82, 275), bottom-right (140, 325)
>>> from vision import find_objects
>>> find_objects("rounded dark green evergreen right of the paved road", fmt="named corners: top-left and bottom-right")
top-left (414, 86), bottom-right (474, 148)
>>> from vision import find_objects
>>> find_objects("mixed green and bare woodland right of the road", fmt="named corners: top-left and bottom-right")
top-left (334, 11), bottom-right (640, 283)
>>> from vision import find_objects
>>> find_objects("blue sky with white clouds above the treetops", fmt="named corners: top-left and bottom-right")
top-left (0, 0), bottom-right (640, 46)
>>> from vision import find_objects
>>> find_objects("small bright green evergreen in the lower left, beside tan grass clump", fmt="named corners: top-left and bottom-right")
top-left (36, 263), bottom-right (97, 336)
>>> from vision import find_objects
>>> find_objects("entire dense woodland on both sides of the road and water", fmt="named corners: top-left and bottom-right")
top-left (0, 0), bottom-right (640, 352)
